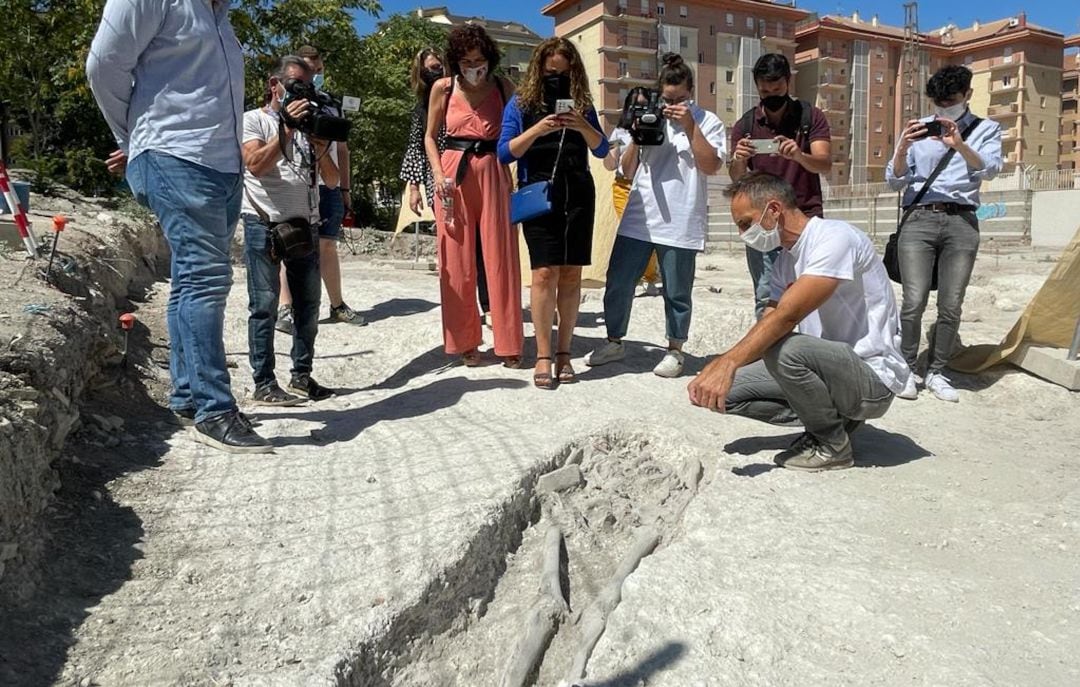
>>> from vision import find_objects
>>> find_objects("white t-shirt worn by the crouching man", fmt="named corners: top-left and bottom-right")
top-left (772, 217), bottom-right (910, 393)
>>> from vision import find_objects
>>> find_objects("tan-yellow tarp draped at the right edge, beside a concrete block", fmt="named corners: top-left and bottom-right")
top-left (949, 225), bottom-right (1080, 374)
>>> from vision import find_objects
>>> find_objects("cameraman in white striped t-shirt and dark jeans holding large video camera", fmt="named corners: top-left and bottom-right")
top-left (241, 55), bottom-right (339, 405)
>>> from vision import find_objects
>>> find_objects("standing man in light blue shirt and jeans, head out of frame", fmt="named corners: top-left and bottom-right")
top-left (86, 0), bottom-right (272, 453)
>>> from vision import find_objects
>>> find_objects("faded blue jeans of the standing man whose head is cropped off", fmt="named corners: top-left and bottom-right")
top-left (127, 150), bottom-right (243, 422)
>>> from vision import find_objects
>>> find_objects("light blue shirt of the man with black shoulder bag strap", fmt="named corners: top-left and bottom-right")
top-left (885, 110), bottom-right (1001, 207)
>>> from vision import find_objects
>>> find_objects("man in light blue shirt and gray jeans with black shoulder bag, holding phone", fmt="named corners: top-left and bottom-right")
top-left (886, 65), bottom-right (1001, 403)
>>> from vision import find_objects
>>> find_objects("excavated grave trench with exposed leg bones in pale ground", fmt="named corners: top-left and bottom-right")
top-left (337, 430), bottom-right (703, 687)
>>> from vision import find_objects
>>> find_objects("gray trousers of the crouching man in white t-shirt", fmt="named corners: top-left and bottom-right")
top-left (725, 334), bottom-right (893, 449)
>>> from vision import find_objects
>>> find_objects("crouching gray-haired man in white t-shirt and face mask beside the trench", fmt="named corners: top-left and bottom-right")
top-left (689, 173), bottom-right (912, 471)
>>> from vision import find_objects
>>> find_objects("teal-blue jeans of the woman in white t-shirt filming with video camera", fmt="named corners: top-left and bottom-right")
top-left (604, 235), bottom-right (698, 344)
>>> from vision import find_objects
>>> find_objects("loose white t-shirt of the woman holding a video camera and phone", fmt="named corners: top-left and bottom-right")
top-left (619, 105), bottom-right (728, 251)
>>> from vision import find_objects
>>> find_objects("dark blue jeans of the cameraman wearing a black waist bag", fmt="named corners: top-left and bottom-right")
top-left (244, 215), bottom-right (323, 389)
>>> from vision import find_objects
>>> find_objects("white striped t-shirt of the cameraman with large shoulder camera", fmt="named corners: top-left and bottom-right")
top-left (242, 107), bottom-right (319, 223)
